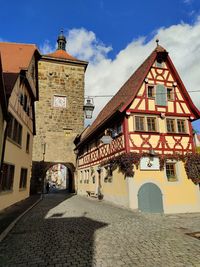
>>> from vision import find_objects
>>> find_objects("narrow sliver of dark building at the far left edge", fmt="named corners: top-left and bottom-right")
top-left (0, 56), bottom-right (8, 171)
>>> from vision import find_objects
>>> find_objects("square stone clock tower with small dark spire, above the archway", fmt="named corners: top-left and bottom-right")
top-left (33, 31), bottom-right (88, 192)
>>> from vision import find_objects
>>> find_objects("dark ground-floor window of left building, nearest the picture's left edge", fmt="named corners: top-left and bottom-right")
top-left (0, 163), bottom-right (15, 191)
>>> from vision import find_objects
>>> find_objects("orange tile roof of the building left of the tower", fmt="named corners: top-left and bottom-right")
top-left (0, 42), bottom-right (39, 73)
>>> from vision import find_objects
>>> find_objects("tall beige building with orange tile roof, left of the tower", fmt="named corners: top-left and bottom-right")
top-left (0, 43), bottom-right (40, 210)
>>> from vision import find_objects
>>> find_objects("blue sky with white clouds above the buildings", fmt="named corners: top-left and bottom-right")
top-left (0, 0), bottom-right (200, 132)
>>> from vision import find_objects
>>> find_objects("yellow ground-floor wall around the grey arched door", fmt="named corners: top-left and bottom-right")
top-left (132, 161), bottom-right (200, 213)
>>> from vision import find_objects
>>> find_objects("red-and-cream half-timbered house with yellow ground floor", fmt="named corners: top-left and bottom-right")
top-left (75, 45), bottom-right (200, 213)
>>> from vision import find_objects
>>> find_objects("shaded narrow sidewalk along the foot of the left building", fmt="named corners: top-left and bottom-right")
top-left (0, 194), bottom-right (41, 239)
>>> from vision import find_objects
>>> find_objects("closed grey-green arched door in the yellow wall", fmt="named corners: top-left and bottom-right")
top-left (138, 183), bottom-right (163, 213)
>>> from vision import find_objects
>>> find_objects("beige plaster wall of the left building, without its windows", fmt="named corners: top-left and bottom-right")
top-left (0, 86), bottom-right (33, 210)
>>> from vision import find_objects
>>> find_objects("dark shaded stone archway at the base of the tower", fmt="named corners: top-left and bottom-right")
top-left (30, 161), bottom-right (75, 194)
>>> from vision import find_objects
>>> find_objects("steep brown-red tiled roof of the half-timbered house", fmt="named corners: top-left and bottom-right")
top-left (79, 45), bottom-right (200, 147)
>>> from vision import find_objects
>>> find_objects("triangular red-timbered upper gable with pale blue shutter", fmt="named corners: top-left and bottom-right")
top-left (129, 56), bottom-right (196, 117)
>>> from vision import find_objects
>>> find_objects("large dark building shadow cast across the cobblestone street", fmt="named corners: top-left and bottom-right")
top-left (0, 192), bottom-right (108, 267)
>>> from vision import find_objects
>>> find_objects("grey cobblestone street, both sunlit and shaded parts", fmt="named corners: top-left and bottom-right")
top-left (0, 194), bottom-right (200, 267)
